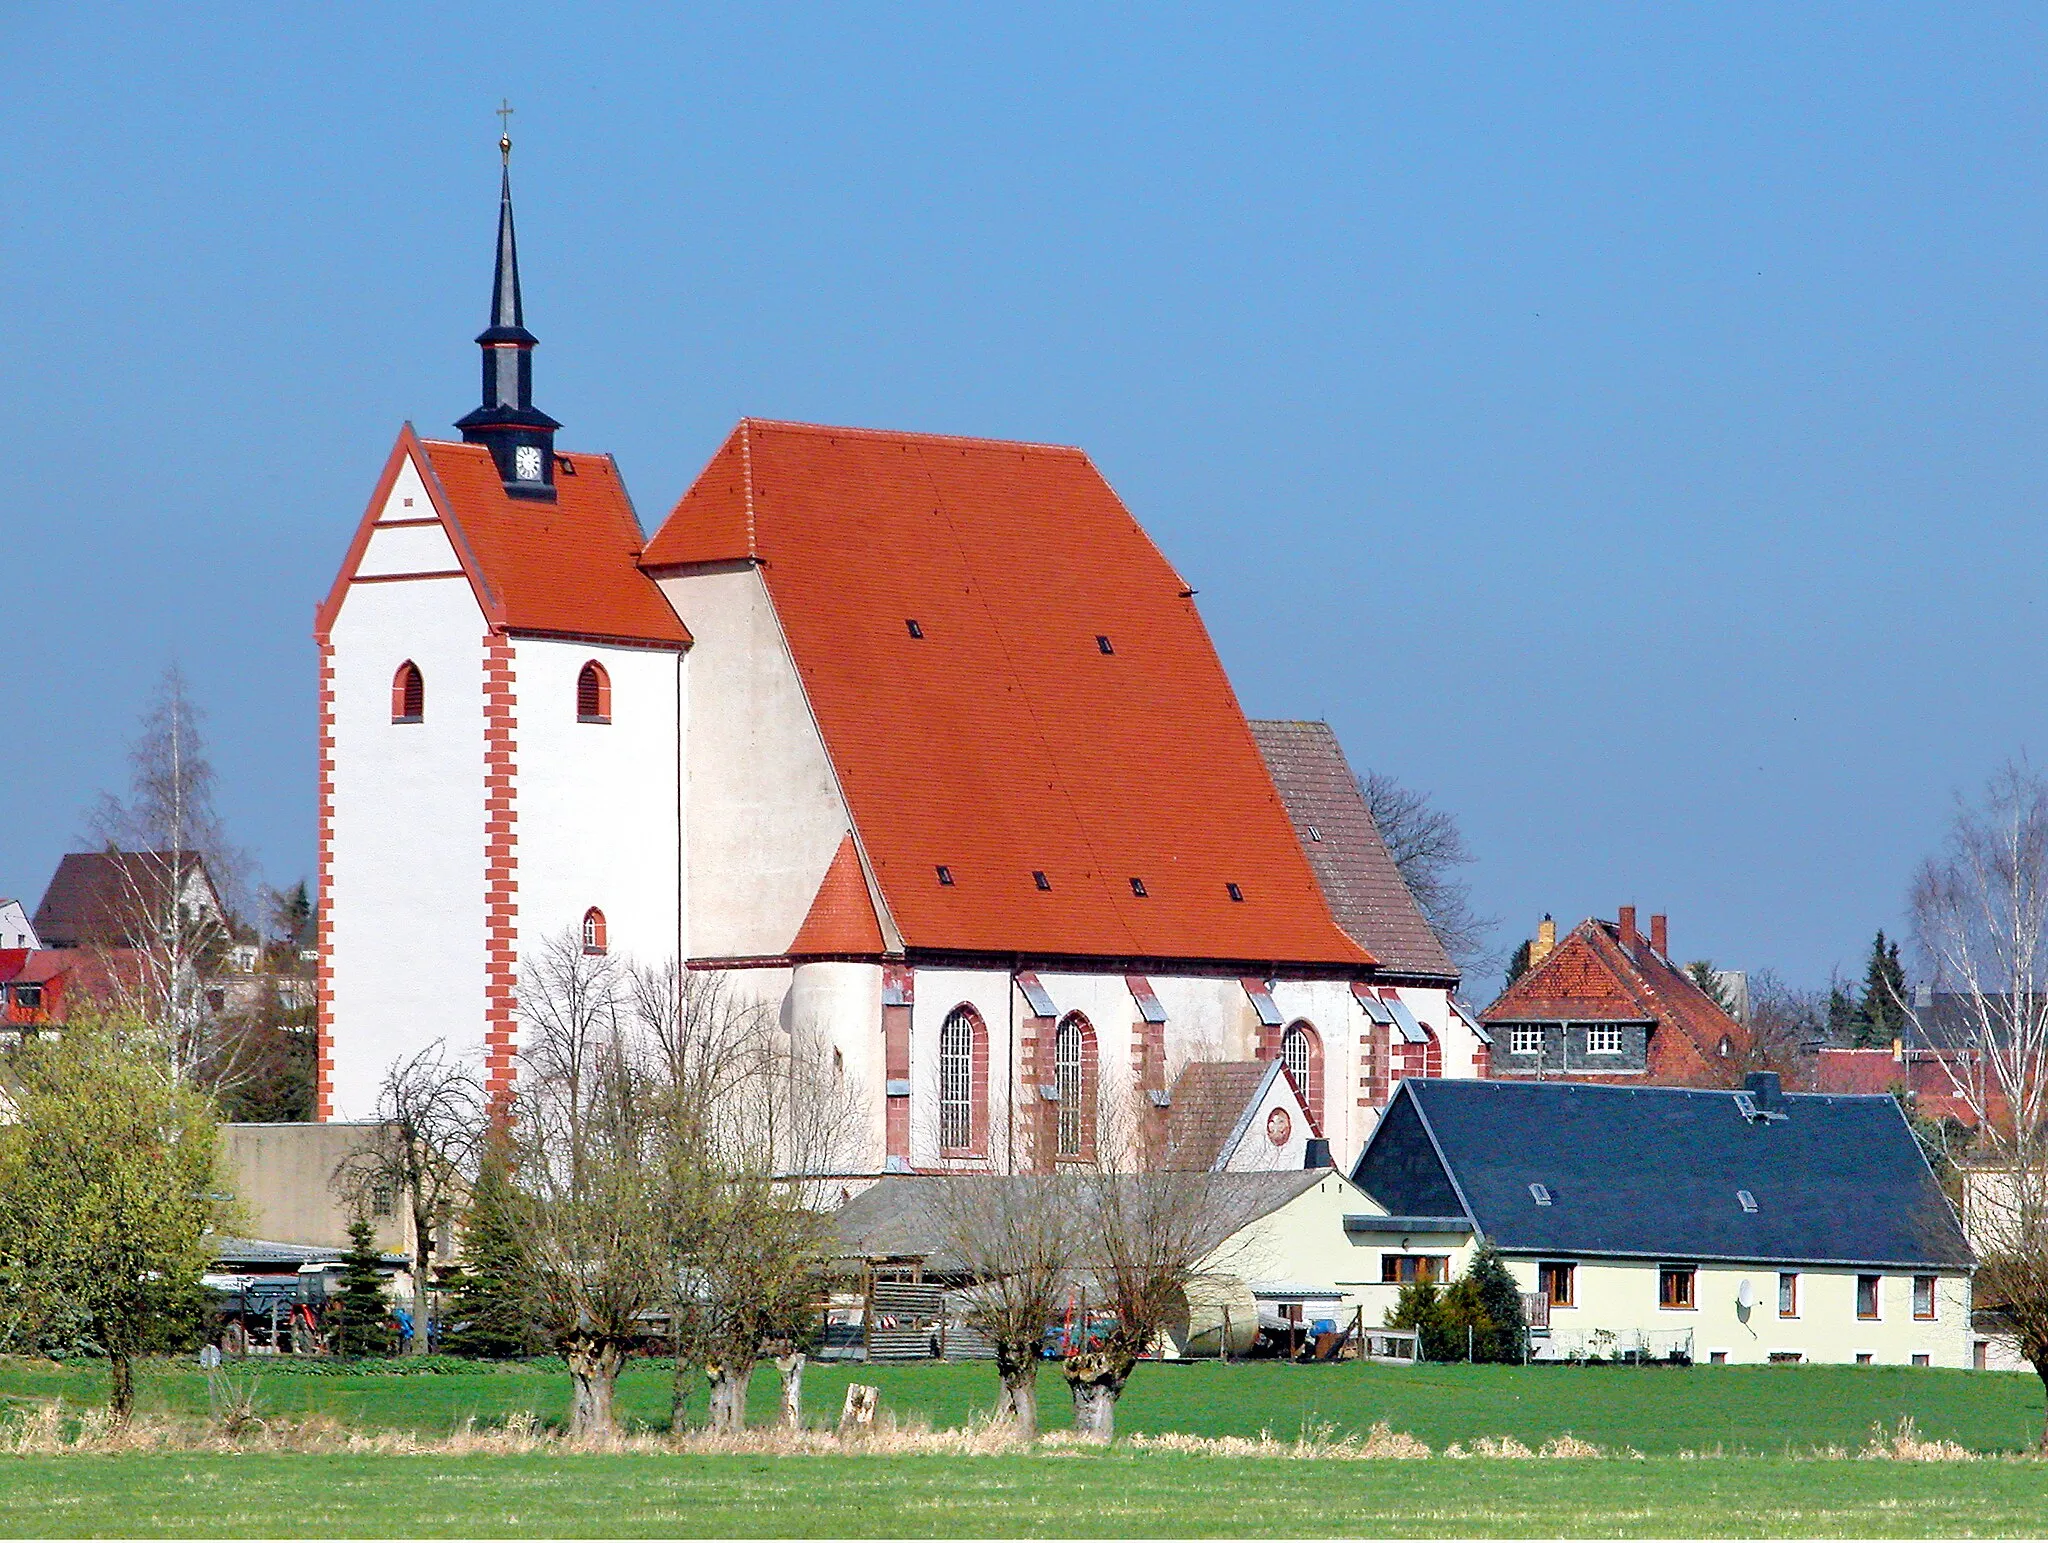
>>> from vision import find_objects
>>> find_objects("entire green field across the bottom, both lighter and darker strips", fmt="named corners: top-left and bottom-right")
top-left (0, 1363), bottom-right (2048, 1537)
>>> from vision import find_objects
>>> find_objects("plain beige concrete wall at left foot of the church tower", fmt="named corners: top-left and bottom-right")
top-left (221, 1123), bottom-right (412, 1254)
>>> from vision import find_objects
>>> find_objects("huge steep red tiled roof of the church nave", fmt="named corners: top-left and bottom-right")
top-left (643, 420), bottom-right (1370, 969)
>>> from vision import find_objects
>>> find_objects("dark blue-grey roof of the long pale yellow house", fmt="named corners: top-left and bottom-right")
top-left (1352, 1080), bottom-right (1974, 1268)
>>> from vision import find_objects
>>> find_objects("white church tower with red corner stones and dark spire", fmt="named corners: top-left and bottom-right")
top-left (313, 137), bottom-right (690, 1119)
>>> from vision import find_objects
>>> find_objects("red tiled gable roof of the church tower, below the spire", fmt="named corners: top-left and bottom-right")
top-left (315, 424), bottom-right (690, 648)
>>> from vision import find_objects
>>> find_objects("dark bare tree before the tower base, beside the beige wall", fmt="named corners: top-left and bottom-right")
top-left (334, 1039), bottom-right (485, 1354)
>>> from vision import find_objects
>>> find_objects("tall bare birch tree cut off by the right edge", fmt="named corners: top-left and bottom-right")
top-left (1898, 760), bottom-right (2048, 1453)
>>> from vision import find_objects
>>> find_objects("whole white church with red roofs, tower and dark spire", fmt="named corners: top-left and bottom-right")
top-left (315, 141), bottom-right (1489, 1174)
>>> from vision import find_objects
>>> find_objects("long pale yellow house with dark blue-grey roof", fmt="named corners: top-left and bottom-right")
top-left (1346, 1072), bottom-right (1976, 1367)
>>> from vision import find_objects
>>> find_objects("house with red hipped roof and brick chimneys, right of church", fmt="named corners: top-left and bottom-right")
top-left (1479, 906), bottom-right (1749, 1088)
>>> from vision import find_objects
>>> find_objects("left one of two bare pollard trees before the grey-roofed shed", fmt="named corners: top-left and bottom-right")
top-left (934, 1172), bottom-right (1083, 1441)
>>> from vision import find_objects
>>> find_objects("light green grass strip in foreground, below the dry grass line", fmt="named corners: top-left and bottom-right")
top-left (0, 1453), bottom-right (2048, 1537)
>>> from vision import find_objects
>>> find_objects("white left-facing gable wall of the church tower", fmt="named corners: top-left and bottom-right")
top-left (322, 450), bottom-right (485, 1119)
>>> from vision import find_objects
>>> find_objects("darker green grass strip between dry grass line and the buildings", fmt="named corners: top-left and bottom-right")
top-left (0, 1359), bottom-right (2042, 1457)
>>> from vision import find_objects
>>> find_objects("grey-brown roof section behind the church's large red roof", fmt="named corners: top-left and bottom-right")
top-left (1251, 717), bottom-right (1458, 984)
